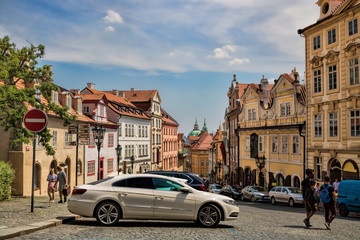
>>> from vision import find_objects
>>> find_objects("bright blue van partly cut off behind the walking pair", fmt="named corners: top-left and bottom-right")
top-left (336, 180), bottom-right (360, 217)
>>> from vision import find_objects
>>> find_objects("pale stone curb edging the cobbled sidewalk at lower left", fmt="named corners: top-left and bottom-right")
top-left (0, 215), bottom-right (80, 240)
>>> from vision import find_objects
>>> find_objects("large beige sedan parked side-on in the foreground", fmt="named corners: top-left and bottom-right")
top-left (68, 174), bottom-right (239, 227)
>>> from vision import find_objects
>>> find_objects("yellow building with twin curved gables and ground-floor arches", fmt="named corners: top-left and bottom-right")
top-left (236, 70), bottom-right (306, 188)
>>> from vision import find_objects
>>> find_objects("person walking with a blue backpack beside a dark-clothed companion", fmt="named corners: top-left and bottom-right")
top-left (320, 176), bottom-right (336, 230)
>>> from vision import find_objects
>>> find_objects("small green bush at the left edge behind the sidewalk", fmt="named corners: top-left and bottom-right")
top-left (0, 161), bottom-right (15, 201)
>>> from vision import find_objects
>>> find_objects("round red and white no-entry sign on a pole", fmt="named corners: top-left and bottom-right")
top-left (23, 109), bottom-right (48, 133)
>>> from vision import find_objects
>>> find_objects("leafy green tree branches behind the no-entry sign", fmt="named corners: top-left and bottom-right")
top-left (0, 36), bottom-right (76, 155)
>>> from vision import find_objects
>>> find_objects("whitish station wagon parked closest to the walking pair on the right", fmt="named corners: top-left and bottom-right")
top-left (269, 186), bottom-right (304, 207)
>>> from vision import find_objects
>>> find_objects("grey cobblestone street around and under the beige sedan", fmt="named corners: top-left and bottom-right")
top-left (12, 201), bottom-right (360, 240)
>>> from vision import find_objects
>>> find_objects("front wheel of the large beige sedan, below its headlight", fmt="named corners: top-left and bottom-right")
top-left (197, 204), bottom-right (221, 227)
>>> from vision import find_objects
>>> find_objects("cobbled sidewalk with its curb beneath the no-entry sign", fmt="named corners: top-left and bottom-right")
top-left (0, 196), bottom-right (79, 240)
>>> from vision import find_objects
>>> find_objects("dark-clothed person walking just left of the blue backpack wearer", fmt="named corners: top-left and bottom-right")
top-left (301, 169), bottom-right (316, 227)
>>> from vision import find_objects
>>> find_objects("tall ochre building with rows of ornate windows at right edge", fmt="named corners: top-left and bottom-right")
top-left (298, 0), bottom-right (360, 181)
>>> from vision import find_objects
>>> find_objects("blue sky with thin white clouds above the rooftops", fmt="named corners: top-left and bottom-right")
top-left (0, 0), bottom-right (319, 135)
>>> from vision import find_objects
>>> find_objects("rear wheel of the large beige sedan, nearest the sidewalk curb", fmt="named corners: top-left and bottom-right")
top-left (95, 202), bottom-right (121, 226)
